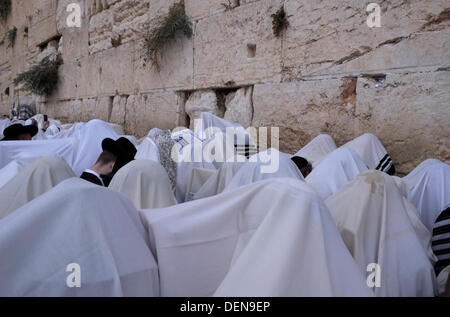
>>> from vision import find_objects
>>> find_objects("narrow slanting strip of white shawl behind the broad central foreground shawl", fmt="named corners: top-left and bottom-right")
top-left (193, 161), bottom-right (245, 200)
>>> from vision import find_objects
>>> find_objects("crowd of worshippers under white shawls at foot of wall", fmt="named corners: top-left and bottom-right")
top-left (0, 113), bottom-right (450, 297)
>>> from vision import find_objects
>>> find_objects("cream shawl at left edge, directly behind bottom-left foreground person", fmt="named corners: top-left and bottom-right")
top-left (0, 157), bottom-right (75, 219)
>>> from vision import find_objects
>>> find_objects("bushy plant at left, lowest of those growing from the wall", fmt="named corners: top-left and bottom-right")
top-left (14, 55), bottom-right (62, 96)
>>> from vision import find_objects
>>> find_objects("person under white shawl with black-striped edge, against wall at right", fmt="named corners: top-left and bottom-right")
top-left (343, 133), bottom-right (395, 175)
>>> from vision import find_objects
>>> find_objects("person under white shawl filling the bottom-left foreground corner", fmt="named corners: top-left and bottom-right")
top-left (0, 178), bottom-right (159, 297)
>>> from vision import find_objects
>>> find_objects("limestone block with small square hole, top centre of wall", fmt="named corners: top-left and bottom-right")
top-left (194, 0), bottom-right (283, 88)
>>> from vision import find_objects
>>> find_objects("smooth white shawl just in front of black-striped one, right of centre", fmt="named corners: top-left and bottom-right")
top-left (306, 147), bottom-right (367, 199)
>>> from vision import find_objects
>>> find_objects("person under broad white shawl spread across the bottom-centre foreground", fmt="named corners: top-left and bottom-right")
top-left (141, 178), bottom-right (373, 297)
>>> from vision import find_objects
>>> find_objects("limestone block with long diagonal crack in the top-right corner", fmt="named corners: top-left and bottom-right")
top-left (283, 0), bottom-right (449, 80)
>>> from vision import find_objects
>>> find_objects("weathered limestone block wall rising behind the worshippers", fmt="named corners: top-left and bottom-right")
top-left (0, 0), bottom-right (450, 172)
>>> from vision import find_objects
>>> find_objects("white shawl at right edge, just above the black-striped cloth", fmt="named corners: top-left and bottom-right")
top-left (410, 162), bottom-right (450, 231)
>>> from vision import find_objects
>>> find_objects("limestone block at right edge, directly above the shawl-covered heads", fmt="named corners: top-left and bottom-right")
top-left (356, 70), bottom-right (450, 173)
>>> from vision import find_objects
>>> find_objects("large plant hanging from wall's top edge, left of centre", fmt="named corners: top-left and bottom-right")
top-left (145, 1), bottom-right (193, 69)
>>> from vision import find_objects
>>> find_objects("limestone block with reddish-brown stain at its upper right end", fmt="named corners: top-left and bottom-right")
top-left (253, 79), bottom-right (356, 153)
